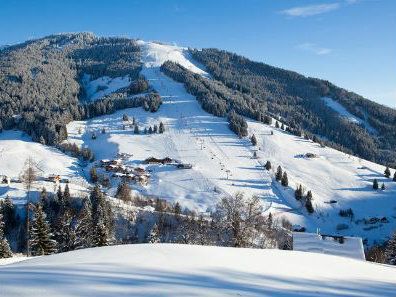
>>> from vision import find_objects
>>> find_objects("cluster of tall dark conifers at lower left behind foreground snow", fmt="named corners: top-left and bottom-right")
top-left (0, 185), bottom-right (114, 258)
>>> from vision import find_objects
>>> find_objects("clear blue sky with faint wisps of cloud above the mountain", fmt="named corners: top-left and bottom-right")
top-left (0, 0), bottom-right (396, 107)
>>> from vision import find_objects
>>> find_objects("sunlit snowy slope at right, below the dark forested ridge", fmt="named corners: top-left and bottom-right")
top-left (248, 120), bottom-right (396, 244)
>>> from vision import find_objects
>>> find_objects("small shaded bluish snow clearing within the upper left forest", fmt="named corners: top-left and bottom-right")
top-left (82, 74), bottom-right (131, 101)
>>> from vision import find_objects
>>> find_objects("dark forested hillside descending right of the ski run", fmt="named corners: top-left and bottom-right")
top-left (191, 49), bottom-right (396, 164)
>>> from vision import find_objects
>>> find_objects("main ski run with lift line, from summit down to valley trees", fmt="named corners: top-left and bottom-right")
top-left (67, 42), bottom-right (277, 211)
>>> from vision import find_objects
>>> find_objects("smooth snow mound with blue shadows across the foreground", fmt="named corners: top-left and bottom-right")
top-left (0, 244), bottom-right (396, 297)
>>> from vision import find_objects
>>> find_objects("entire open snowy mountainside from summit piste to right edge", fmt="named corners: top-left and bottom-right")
top-left (67, 41), bottom-right (396, 244)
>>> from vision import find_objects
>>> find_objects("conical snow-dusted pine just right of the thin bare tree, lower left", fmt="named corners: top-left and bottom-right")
top-left (29, 204), bottom-right (56, 256)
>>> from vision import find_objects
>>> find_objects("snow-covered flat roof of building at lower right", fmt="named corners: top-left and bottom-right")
top-left (293, 232), bottom-right (366, 260)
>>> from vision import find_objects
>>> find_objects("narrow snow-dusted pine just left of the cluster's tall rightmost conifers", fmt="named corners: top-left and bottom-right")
top-left (76, 199), bottom-right (93, 249)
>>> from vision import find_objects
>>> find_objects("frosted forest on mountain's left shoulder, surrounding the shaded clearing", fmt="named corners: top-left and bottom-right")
top-left (0, 33), bottom-right (145, 145)
